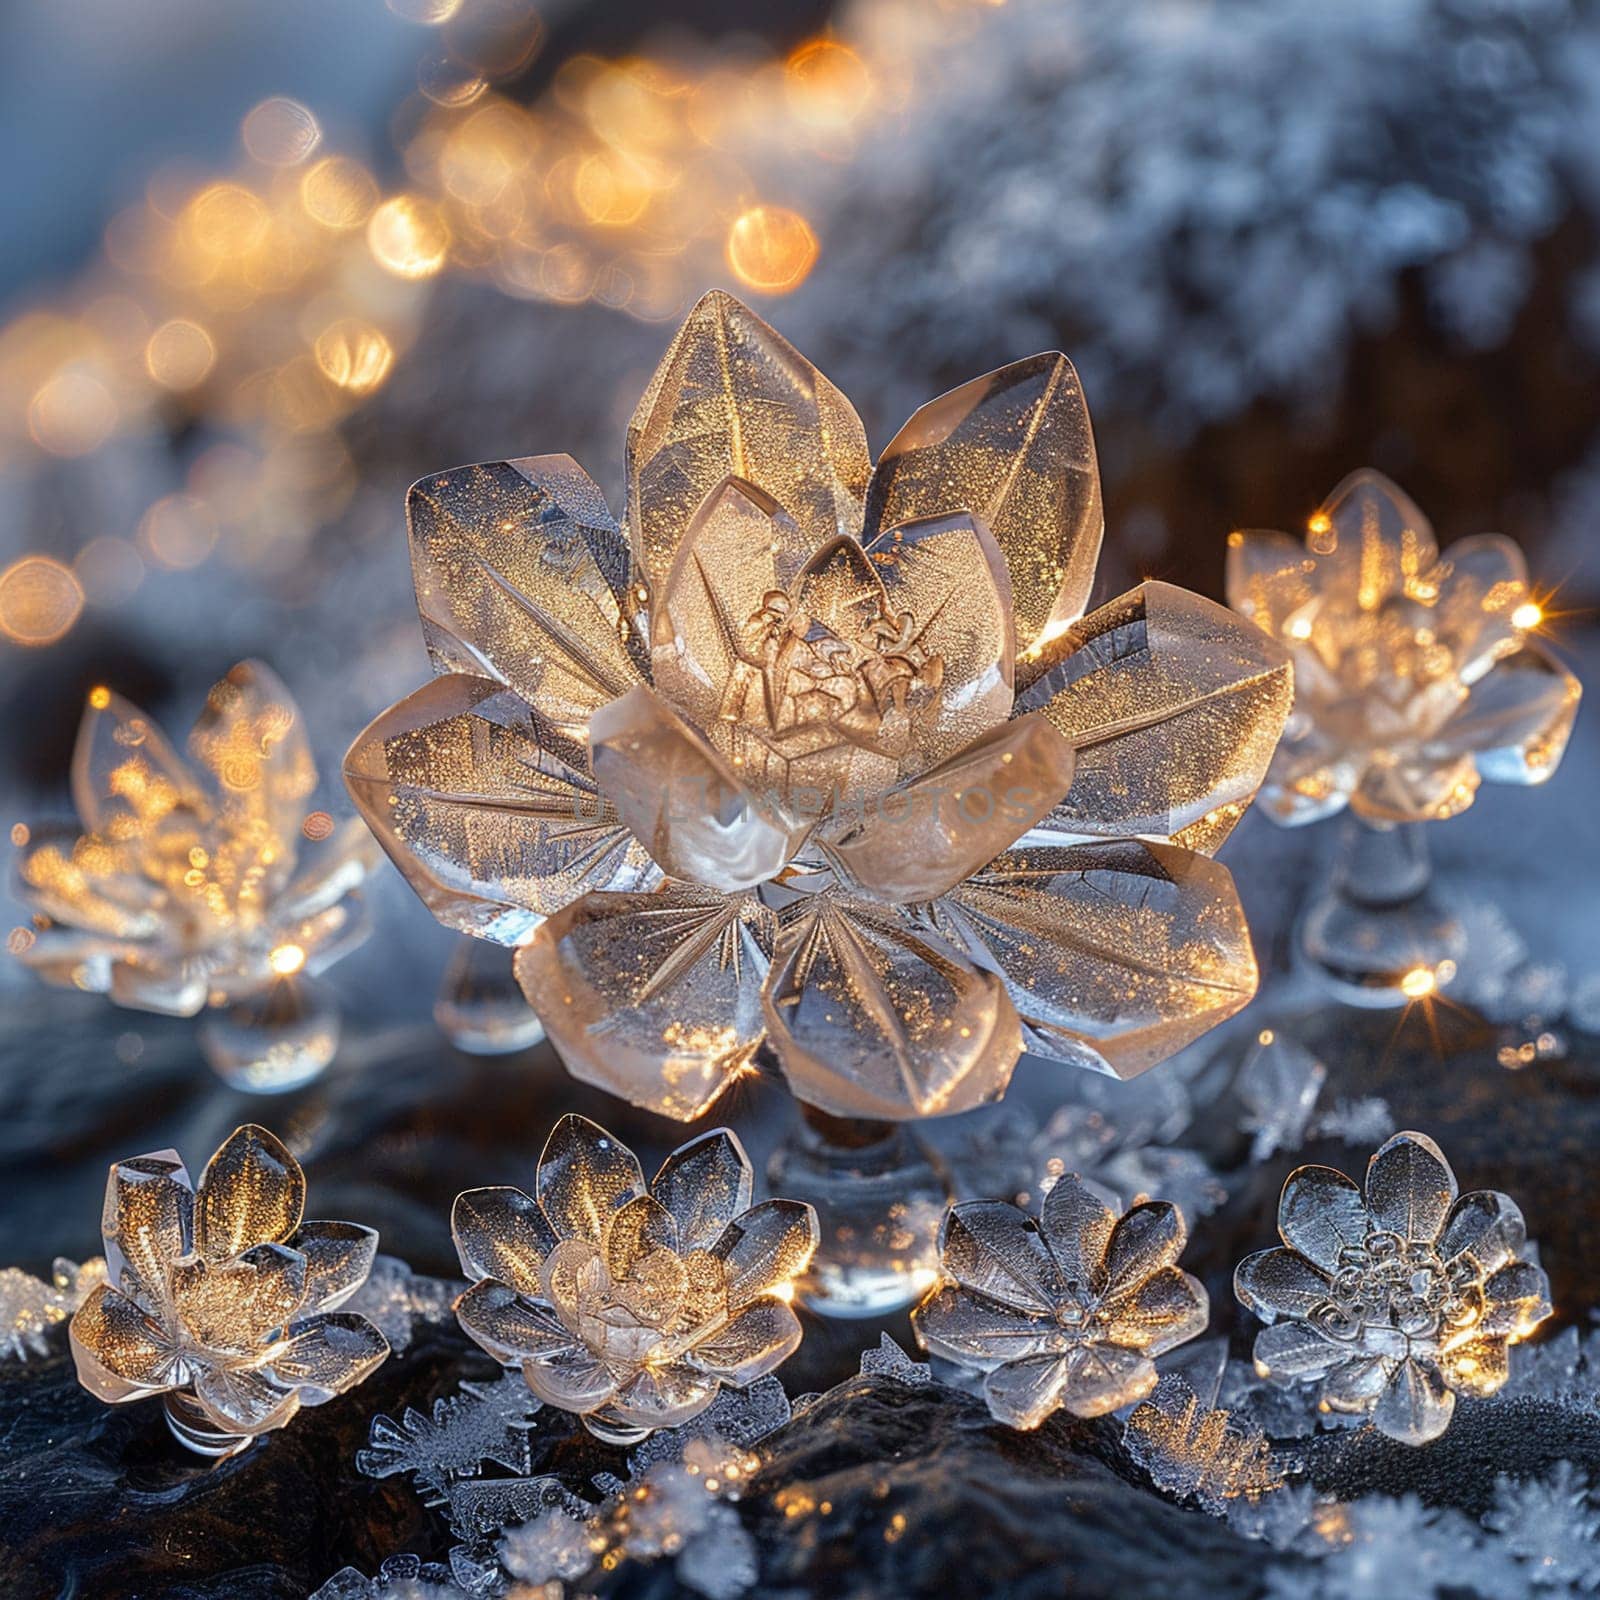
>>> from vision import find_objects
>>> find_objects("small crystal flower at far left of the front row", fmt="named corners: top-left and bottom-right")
top-left (69, 1125), bottom-right (389, 1456)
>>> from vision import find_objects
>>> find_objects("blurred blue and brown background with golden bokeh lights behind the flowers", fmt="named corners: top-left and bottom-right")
top-left (0, 0), bottom-right (1600, 1027)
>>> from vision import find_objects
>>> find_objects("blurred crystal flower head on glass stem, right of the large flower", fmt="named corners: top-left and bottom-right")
top-left (1227, 470), bottom-right (1581, 824)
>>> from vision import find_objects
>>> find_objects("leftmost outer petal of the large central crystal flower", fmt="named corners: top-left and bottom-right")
top-left (344, 675), bottom-right (658, 944)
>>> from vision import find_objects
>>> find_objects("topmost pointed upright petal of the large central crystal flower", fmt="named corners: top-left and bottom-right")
top-left (627, 290), bottom-right (870, 586)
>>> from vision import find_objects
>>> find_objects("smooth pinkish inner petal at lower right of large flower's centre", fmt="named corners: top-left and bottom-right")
top-left (827, 715), bottom-right (1072, 904)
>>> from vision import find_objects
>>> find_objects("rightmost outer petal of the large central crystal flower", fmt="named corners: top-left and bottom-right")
top-left (1018, 582), bottom-right (1294, 850)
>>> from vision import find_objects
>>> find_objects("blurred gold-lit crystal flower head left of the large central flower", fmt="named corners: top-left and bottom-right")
top-left (13, 661), bottom-right (378, 1016)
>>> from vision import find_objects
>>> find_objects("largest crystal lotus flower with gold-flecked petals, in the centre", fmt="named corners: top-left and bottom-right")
top-left (346, 293), bottom-right (1291, 1120)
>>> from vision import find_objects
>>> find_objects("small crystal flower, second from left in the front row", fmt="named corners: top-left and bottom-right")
top-left (451, 1115), bottom-right (818, 1443)
